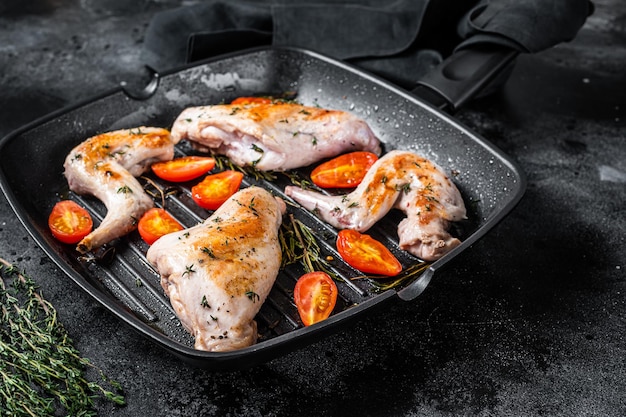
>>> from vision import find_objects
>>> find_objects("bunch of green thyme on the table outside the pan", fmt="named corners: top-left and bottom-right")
top-left (0, 258), bottom-right (125, 416)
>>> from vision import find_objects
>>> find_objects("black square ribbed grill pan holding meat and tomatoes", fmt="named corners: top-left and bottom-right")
top-left (0, 48), bottom-right (525, 369)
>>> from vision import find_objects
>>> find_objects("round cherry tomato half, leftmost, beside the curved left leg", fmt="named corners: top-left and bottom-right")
top-left (48, 200), bottom-right (93, 243)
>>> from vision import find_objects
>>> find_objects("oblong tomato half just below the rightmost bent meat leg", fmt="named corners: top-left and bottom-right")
top-left (337, 229), bottom-right (402, 276)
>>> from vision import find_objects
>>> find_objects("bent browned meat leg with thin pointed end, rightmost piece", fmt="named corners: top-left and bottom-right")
top-left (285, 151), bottom-right (466, 261)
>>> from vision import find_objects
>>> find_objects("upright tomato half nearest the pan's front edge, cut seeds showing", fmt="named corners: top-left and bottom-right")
top-left (293, 271), bottom-right (337, 326)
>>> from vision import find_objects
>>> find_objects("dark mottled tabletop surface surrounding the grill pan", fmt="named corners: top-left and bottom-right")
top-left (0, 0), bottom-right (626, 417)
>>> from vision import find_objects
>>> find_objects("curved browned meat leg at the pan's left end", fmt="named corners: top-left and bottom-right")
top-left (64, 126), bottom-right (174, 253)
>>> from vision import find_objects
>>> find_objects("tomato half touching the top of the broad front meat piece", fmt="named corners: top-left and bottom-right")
top-left (191, 171), bottom-right (243, 210)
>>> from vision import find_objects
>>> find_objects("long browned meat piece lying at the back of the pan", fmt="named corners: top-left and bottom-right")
top-left (172, 102), bottom-right (381, 171)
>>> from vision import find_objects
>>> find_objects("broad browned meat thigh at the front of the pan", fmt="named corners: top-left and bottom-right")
top-left (147, 187), bottom-right (285, 352)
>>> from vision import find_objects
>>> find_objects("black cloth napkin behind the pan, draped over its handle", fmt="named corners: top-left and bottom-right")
top-left (143, 0), bottom-right (593, 88)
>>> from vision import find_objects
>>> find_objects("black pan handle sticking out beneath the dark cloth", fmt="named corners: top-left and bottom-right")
top-left (412, 43), bottom-right (519, 113)
